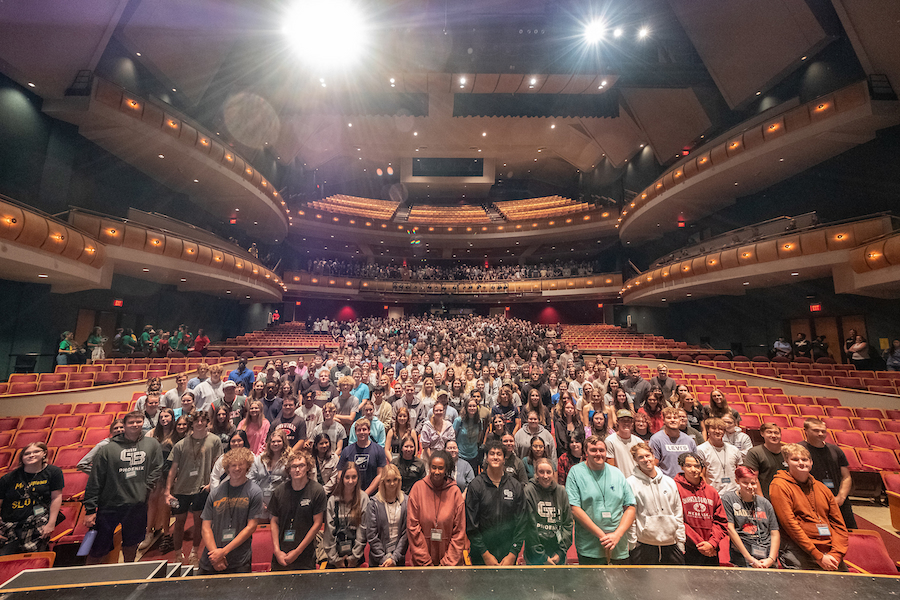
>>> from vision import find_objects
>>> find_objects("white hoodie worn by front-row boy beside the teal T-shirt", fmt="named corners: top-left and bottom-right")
top-left (627, 467), bottom-right (685, 552)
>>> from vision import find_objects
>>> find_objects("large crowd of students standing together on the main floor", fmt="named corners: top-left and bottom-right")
top-left (0, 317), bottom-right (855, 574)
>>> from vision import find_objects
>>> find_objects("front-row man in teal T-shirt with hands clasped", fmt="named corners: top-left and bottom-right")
top-left (566, 435), bottom-right (636, 565)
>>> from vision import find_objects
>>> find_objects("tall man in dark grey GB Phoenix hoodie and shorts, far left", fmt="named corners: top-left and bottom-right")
top-left (84, 411), bottom-right (163, 564)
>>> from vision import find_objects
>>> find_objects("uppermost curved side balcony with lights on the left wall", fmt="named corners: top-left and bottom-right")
top-left (43, 77), bottom-right (288, 241)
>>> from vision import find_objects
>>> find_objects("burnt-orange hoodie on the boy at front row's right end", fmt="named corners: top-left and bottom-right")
top-left (769, 471), bottom-right (848, 561)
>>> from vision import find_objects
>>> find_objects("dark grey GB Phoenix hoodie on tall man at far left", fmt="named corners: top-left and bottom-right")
top-left (84, 433), bottom-right (163, 515)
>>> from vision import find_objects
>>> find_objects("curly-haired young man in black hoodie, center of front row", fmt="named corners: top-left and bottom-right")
top-left (466, 442), bottom-right (525, 566)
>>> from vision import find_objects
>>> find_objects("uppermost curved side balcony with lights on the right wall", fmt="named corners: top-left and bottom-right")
top-left (619, 81), bottom-right (900, 243)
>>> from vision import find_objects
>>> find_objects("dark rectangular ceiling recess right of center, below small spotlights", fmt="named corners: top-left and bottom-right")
top-left (453, 90), bottom-right (619, 119)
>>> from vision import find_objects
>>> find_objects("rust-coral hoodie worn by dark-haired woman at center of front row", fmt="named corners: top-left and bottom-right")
top-left (407, 477), bottom-right (466, 567)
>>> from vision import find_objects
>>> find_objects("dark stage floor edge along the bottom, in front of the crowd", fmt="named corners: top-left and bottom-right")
top-left (0, 567), bottom-right (900, 600)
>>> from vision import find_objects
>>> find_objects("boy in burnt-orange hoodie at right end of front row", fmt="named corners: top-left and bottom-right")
top-left (769, 444), bottom-right (849, 571)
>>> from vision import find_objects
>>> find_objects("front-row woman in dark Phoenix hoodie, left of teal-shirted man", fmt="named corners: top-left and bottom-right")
top-left (525, 458), bottom-right (572, 565)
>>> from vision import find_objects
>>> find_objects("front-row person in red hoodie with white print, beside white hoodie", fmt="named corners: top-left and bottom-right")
top-left (675, 452), bottom-right (728, 567)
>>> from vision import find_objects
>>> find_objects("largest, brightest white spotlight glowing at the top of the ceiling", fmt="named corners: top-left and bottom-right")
top-left (283, 0), bottom-right (369, 68)
